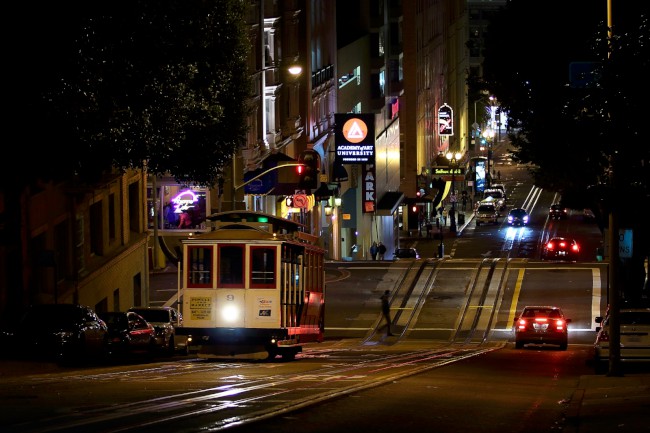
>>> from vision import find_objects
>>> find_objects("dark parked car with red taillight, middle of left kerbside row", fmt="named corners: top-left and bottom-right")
top-left (100, 311), bottom-right (158, 357)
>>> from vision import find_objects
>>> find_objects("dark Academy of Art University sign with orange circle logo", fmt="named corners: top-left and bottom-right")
top-left (334, 113), bottom-right (375, 164)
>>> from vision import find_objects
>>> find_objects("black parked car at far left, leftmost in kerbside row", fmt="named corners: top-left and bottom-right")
top-left (5, 304), bottom-right (108, 363)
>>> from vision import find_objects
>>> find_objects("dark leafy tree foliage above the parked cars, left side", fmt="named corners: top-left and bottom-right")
top-left (7, 0), bottom-right (250, 186)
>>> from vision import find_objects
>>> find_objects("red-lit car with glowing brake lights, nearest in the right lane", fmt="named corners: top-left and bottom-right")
top-left (515, 305), bottom-right (571, 350)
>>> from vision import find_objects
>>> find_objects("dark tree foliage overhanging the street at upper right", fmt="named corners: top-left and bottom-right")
top-left (479, 0), bottom-right (650, 216)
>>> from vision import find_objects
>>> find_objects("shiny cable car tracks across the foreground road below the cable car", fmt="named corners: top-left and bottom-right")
top-left (3, 345), bottom-right (498, 433)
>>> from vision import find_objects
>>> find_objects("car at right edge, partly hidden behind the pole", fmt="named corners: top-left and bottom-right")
top-left (594, 306), bottom-right (650, 374)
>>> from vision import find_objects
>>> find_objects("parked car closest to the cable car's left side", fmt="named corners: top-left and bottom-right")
top-left (129, 307), bottom-right (189, 355)
